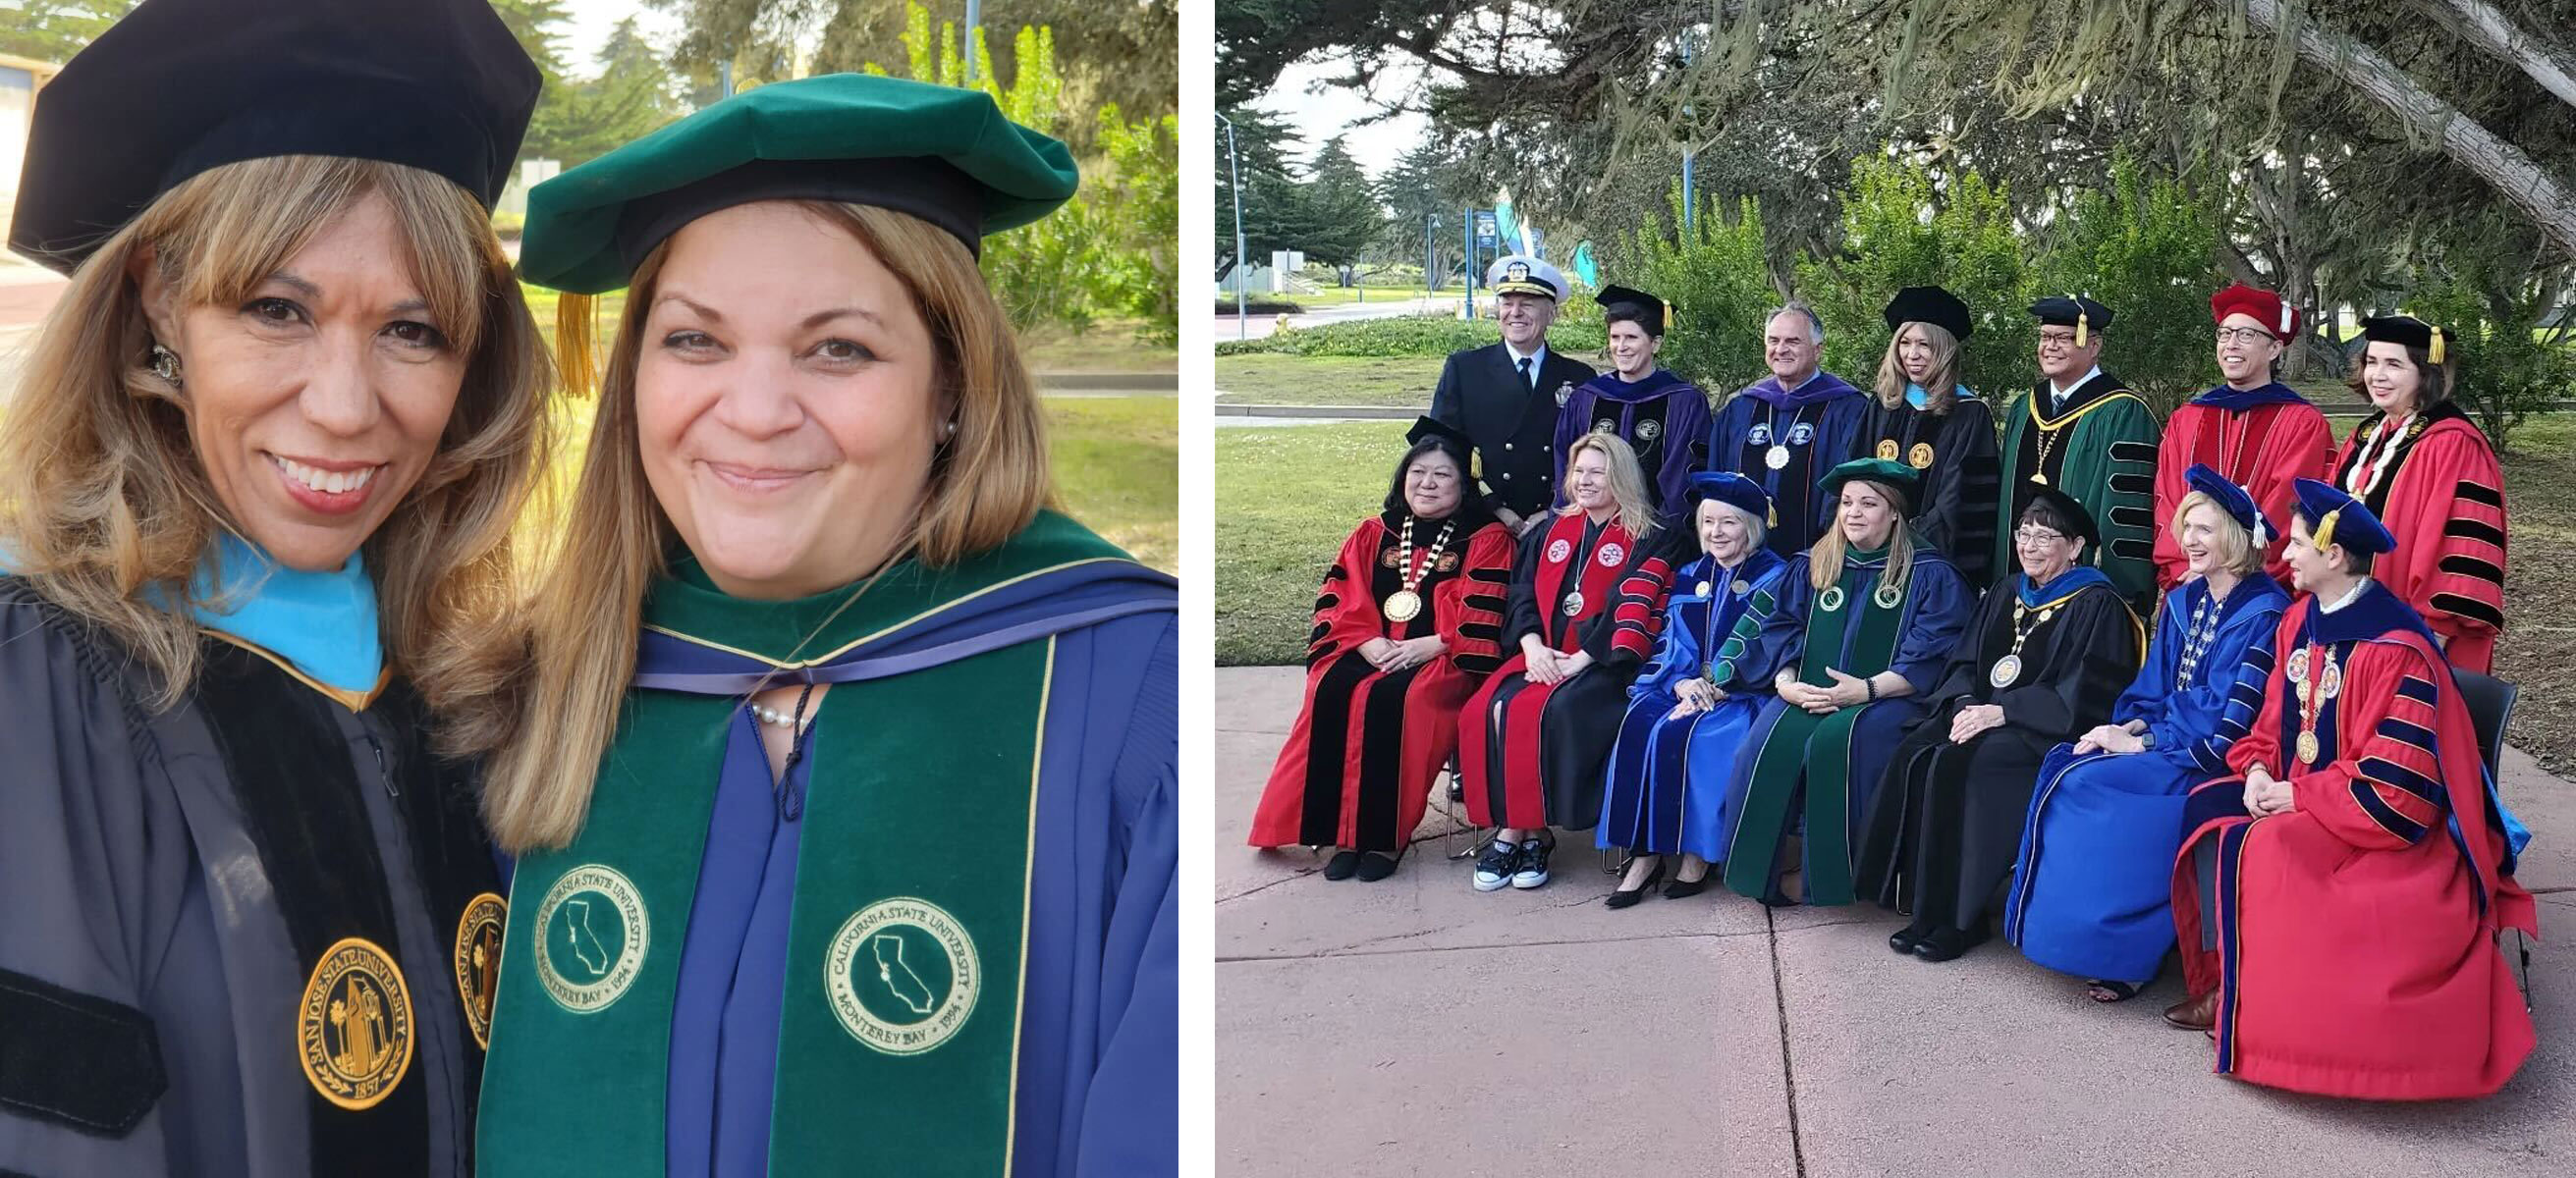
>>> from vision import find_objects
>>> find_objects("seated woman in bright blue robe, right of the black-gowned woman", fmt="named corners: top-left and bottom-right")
top-left (2004, 466), bottom-right (2290, 1002)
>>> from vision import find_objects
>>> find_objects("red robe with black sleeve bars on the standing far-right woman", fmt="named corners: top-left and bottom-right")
top-left (2329, 402), bottom-right (2504, 675)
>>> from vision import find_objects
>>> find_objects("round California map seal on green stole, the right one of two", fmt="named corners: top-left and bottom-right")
top-left (822, 897), bottom-right (984, 1054)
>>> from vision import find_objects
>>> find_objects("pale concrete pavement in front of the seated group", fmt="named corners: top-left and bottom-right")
top-left (1213, 668), bottom-right (2576, 1178)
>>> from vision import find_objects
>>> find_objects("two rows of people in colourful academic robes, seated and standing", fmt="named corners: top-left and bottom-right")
top-left (1249, 258), bottom-right (2538, 1098)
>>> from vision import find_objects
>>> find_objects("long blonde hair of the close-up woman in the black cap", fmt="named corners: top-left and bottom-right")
top-left (0, 155), bottom-right (554, 726)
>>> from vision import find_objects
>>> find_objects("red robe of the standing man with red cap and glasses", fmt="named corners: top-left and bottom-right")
top-left (2156, 400), bottom-right (2333, 598)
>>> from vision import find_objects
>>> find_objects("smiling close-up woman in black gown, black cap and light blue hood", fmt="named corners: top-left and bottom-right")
top-left (0, 0), bottom-right (551, 1178)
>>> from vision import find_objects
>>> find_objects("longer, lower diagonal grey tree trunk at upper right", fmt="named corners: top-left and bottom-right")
top-left (2244, 0), bottom-right (2576, 255)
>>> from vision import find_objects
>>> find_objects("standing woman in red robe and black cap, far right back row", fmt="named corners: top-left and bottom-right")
top-left (2333, 314), bottom-right (2504, 675)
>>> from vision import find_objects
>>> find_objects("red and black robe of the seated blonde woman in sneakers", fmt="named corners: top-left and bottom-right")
top-left (1458, 513), bottom-right (1674, 830)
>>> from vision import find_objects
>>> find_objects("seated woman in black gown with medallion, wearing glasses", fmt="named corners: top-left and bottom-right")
top-left (1860, 487), bottom-right (2146, 961)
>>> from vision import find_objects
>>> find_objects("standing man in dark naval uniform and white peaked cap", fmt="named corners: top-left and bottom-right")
top-left (1430, 252), bottom-right (1592, 534)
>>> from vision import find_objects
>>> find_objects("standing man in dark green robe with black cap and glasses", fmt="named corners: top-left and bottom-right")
top-left (1994, 294), bottom-right (2179, 614)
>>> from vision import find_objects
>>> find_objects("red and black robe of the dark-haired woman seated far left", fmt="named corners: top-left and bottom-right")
top-left (1247, 515), bottom-right (1512, 853)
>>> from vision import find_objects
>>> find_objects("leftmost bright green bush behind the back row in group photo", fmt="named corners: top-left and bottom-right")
top-left (1603, 183), bottom-right (1778, 395)
